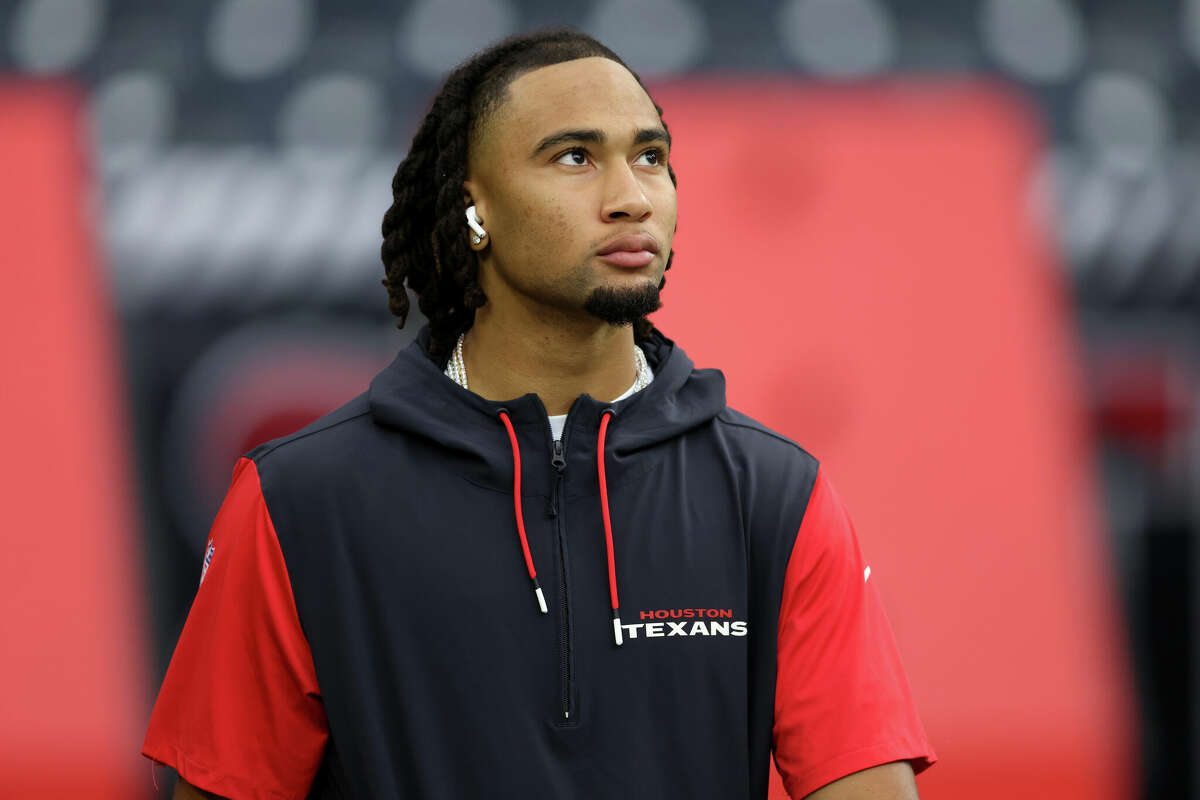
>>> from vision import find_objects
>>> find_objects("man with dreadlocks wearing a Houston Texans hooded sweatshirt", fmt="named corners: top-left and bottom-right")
top-left (143, 31), bottom-right (936, 800)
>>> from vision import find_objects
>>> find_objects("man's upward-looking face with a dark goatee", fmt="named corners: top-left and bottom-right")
top-left (463, 58), bottom-right (676, 324)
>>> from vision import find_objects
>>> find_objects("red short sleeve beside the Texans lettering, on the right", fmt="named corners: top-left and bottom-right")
top-left (774, 469), bottom-right (937, 800)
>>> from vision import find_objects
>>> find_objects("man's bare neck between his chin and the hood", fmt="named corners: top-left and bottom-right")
top-left (463, 301), bottom-right (637, 415)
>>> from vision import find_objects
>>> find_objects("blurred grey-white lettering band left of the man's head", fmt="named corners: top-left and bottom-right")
top-left (103, 146), bottom-right (397, 317)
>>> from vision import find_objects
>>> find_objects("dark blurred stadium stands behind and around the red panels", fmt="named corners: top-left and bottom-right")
top-left (0, 0), bottom-right (1200, 798)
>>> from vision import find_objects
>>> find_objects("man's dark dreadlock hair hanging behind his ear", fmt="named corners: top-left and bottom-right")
top-left (379, 28), bottom-right (676, 363)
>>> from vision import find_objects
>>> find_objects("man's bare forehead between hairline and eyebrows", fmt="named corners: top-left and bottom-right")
top-left (490, 56), bottom-right (659, 148)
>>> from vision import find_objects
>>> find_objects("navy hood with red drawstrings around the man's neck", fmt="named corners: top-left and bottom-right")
top-left (367, 324), bottom-right (725, 645)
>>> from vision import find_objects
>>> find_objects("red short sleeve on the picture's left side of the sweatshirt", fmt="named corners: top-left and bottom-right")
top-left (142, 458), bottom-right (329, 800)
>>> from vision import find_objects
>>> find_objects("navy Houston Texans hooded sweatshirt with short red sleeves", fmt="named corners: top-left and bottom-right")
top-left (142, 326), bottom-right (936, 800)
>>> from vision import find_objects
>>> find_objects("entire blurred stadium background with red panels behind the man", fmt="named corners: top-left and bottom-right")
top-left (0, 0), bottom-right (1200, 800)
